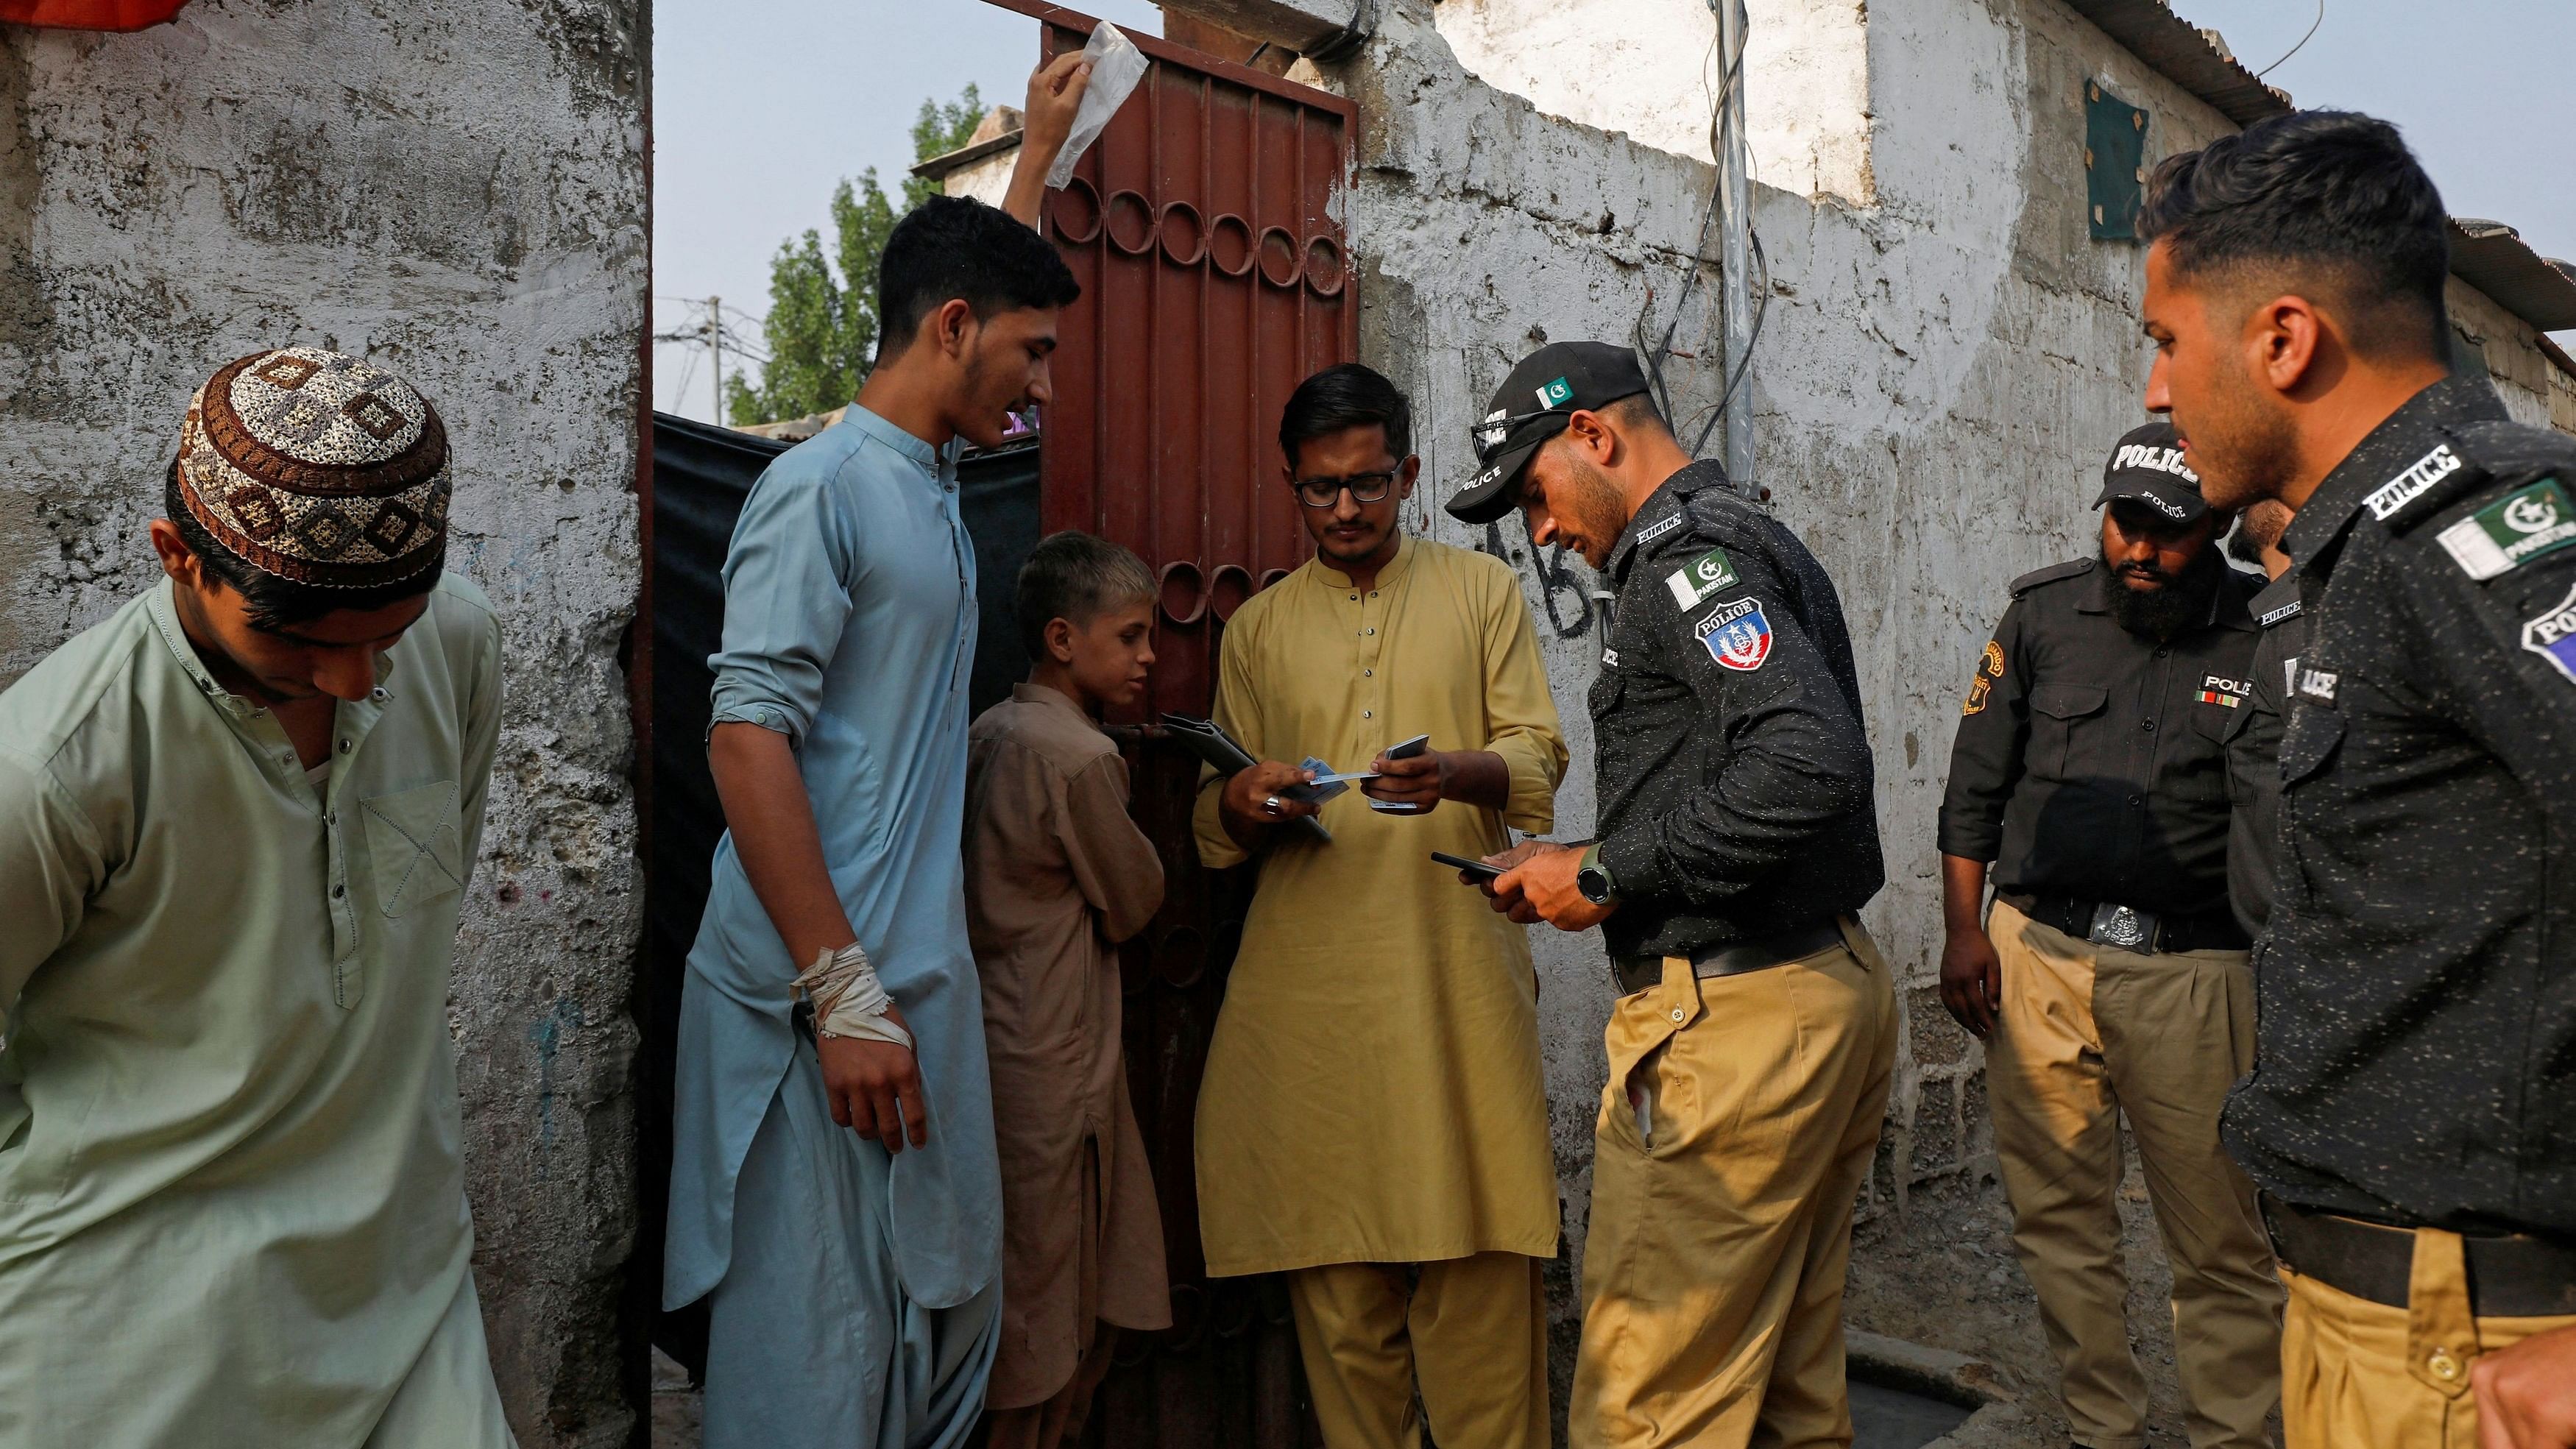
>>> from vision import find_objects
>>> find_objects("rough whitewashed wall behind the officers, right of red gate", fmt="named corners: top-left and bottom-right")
top-left (1226, 0), bottom-right (2229, 1444)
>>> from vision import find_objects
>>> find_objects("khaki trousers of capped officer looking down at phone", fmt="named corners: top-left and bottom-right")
top-left (1569, 919), bottom-right (1896, 1449)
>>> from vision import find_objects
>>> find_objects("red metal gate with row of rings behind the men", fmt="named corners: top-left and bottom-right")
top-left (997, 0), bottom-right (1358, 1449)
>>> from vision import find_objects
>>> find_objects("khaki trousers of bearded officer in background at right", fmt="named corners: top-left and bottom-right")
top-left (1986, 901), bottom-right (2282, 1449)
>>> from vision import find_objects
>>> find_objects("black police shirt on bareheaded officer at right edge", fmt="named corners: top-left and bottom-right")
top-left (2226, 378), bottom-right (2576, 1236)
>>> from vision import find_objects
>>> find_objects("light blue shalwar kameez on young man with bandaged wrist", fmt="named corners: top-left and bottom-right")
top-left (662, 407), bottom-right (1002, 1449)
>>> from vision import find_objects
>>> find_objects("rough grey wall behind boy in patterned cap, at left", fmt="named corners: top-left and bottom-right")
top-left (0, 0), bottom-right (647, 1447)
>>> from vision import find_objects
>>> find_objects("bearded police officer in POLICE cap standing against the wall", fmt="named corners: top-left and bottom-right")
top-left (1940, 422), bottom-right (2280, 1449)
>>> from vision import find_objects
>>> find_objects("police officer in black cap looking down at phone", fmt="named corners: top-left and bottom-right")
top-left (1448, 342), bottom-right (1896, 1449)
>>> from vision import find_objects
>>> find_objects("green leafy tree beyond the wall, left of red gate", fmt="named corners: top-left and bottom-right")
top-left (724, 85), bottom-right (1005, 425)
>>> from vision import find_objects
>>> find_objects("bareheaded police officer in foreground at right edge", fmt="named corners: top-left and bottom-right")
top-left (2141, 110), bottom-right (2576, 1449)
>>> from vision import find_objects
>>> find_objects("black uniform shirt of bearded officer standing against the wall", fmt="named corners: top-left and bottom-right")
top-left (1940, 559), bottom-right (2254, 916)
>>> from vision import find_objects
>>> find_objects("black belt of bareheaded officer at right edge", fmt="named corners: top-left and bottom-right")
top-left (2262, 1191), bottom-right (2576, 1318)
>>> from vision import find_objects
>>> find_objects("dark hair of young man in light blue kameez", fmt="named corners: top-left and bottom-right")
top-left (876, 196), bottom-right (1082, 358)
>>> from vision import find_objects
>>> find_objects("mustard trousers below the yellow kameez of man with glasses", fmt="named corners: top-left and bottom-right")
top-left (1288, 1253), bottom-right (1549, 1449)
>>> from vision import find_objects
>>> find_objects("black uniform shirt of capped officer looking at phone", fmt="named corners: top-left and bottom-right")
top-left (1592, 464), bottom-right (1886, 957)
